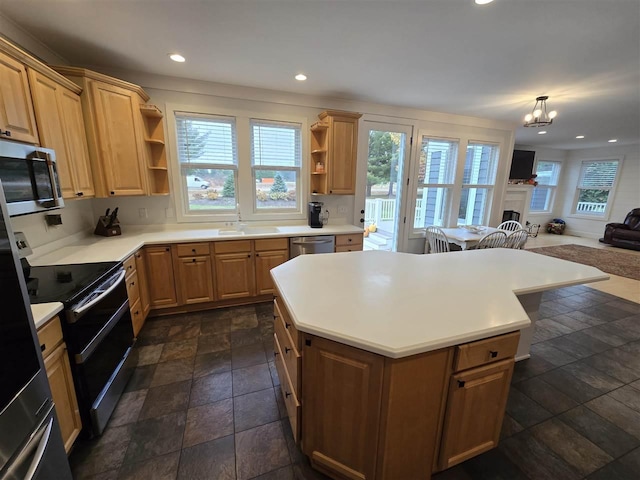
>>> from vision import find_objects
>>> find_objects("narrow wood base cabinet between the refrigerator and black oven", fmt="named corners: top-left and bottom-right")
top-left (38, 317), bottom-right (82, 453)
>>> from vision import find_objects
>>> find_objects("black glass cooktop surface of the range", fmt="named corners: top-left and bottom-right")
top-left (23, 262), bottom-right (120, 307)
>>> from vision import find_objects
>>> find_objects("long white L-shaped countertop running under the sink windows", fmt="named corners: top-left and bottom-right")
top-left (28, 225), bottom-right (362, 266)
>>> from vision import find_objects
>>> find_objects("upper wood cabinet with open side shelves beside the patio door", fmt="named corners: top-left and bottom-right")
top-left (311, 110), bottom-right (362, 195)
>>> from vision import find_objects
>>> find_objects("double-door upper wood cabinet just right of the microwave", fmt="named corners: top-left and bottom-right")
top-left (29, 69), bottom-right (95, 198)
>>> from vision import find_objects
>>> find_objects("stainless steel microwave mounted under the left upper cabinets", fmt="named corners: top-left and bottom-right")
top-left (0, 141), bottom-right (64, 217)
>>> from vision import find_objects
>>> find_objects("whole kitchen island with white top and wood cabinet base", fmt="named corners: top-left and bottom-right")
top-left (272, 249), bottom-right (608, 479)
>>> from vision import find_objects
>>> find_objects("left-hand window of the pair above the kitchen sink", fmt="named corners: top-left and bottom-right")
top-left (176, 114), bottom-right (238, 214)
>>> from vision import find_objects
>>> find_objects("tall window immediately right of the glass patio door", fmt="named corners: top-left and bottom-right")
top-left (413, 136), bottom-right (458, 230)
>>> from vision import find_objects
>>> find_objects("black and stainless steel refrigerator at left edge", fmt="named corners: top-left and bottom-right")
top-left (0, 183), bottom-right (72, 480)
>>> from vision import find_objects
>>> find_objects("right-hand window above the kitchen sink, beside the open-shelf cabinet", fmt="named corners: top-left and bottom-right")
top-left (251, 120), bottom-right (302, 211)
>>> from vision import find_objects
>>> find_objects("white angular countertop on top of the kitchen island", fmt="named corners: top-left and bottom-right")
top-left (271, 248), bottom-right (609, 358)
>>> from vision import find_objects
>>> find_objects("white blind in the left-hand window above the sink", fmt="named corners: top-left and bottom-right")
top-left (176, 115), bottom-right (238, 166)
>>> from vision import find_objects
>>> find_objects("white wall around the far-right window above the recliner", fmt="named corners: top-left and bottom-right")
top-left (554, 145), bottom-right (640, 238)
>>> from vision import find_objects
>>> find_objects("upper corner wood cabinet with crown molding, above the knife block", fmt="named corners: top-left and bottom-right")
top-left (54, 67), bottom-right (149, 197)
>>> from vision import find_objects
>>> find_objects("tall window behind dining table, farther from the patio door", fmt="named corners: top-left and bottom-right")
top-left (458, 143), bottom-right (499, 225)
